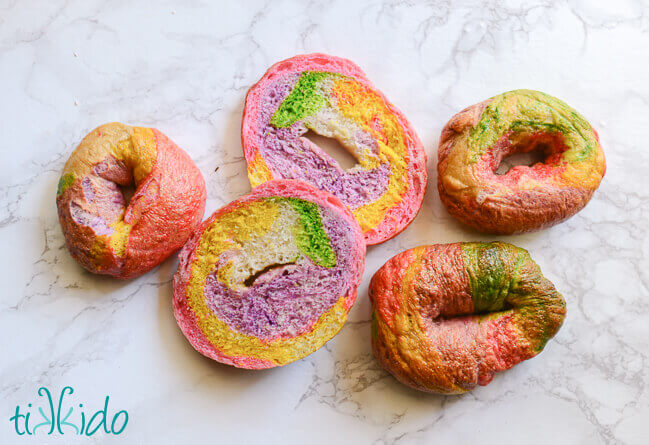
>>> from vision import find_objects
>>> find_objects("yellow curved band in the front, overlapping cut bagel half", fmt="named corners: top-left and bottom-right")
top-left (187, 200), bottom-right (347, 365)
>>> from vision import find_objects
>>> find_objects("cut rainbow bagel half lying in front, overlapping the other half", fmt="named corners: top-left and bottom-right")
top-left (174, 180), bottom-right (365, 369)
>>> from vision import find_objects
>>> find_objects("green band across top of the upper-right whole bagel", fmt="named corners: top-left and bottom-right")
top-left (468, 90), bottom-right (597, 163)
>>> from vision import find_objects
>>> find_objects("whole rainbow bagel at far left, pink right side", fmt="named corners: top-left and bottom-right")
top-left (56, 122), bottom-right (205, 278)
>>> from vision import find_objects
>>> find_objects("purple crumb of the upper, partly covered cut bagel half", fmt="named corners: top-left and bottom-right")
top-left (257, 74), bottom-right (390, 209)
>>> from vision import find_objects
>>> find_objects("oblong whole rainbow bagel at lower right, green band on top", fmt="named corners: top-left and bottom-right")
top-left (370, 243), bottom-right (566, 394)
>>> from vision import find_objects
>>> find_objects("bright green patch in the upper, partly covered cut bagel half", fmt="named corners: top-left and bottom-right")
top-left (270, 71), bottom-right (333, 128)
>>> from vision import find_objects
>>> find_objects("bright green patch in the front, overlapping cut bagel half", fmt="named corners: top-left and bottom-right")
top-left (268, 198), bottom-right (336, 267)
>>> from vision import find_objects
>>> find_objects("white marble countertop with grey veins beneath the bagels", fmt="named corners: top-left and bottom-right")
top-left (0, 0), bottom-right (649, 445)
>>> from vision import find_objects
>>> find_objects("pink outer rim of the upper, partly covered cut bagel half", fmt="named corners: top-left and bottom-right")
top-left (241, 53), bottom-right (428, 245)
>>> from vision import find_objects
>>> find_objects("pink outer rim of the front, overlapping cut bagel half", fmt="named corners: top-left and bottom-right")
top-left (173, 179), bottom-right (365, 369)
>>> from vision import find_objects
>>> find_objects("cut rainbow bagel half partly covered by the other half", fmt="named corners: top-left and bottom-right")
top-left (241, 54), bottom-right (427, 244)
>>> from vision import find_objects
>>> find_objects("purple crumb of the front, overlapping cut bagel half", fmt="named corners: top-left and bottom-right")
top-left (204, 207), bottom-right (357, 341)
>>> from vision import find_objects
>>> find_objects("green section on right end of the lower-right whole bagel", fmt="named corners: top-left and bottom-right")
top-left (462, 242), bottom-right (566, 352)
